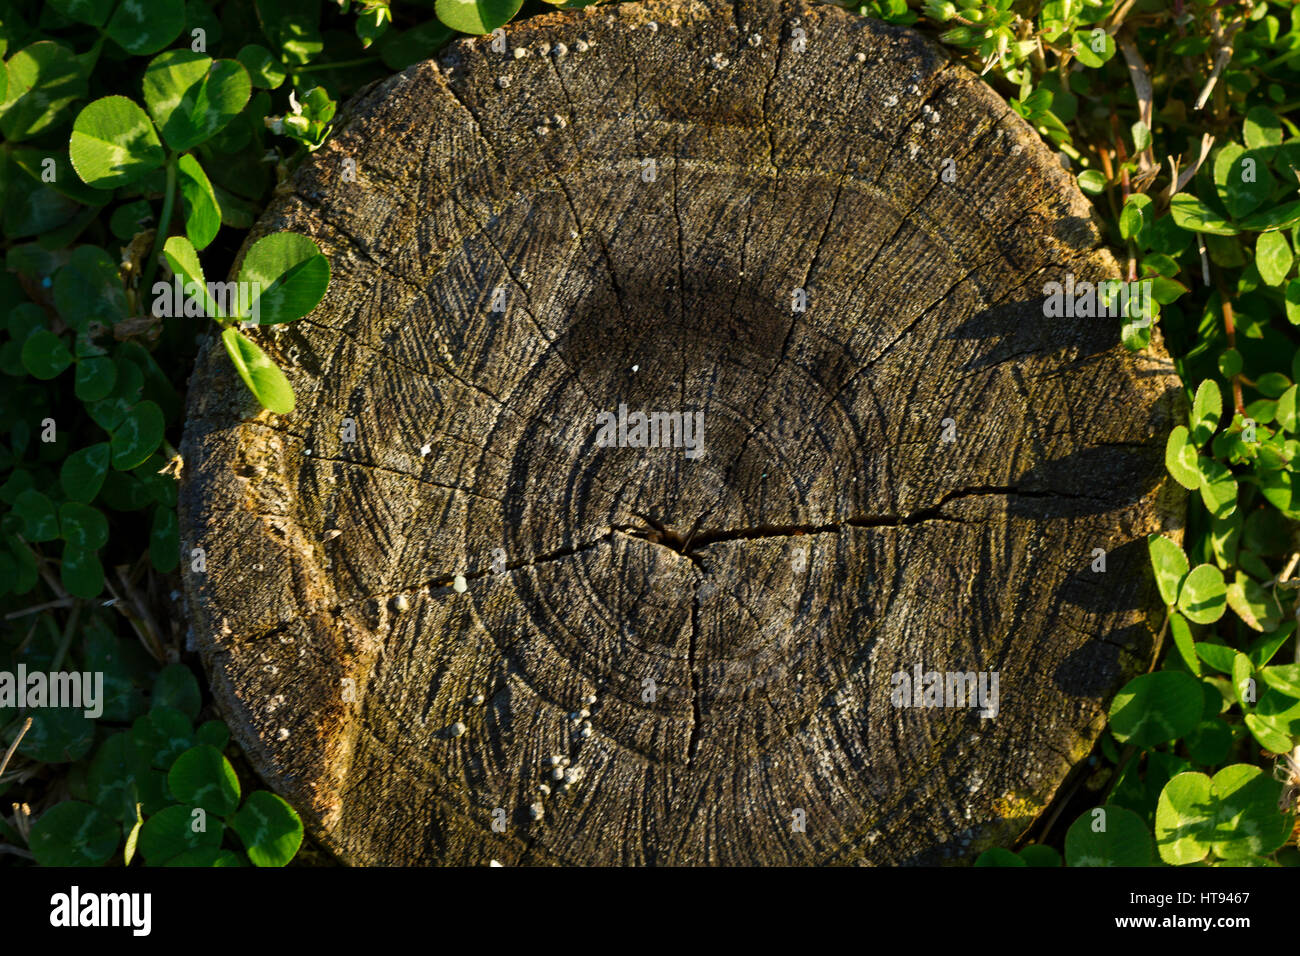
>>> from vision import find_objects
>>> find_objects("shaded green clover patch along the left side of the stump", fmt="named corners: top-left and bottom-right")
top-left (0, 0), bottom-right (421, 865)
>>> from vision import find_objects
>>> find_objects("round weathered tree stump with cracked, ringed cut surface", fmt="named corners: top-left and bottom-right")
top-left (182, 0), bottom-right (1182, 865)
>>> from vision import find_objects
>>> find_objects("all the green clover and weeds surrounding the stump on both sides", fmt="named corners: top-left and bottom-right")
top-left (0, 0), bottom-right (1300, 866)
